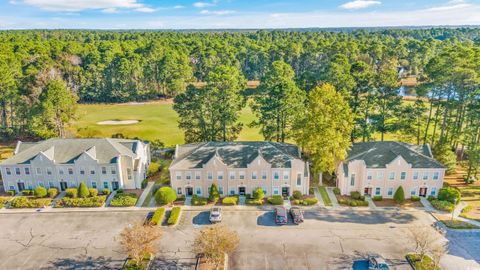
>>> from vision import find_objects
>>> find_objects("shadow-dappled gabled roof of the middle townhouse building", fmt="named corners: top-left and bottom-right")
top-left (170, 142), bottom-right (301, 169)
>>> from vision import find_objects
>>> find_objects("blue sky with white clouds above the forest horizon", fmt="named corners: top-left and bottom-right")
top-left (0, 0), bottom-right (480, 29)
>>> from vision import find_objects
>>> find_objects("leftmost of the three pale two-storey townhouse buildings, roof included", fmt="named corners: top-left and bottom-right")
top-left (0, 138), bottom-right (150, 192)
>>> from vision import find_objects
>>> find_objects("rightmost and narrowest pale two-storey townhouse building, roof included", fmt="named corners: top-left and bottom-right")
top-left (336, 141), bottom-right (446, 198)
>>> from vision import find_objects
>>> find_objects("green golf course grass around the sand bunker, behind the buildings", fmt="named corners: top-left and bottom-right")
top-left (71, 100), bottom-right (263, 146)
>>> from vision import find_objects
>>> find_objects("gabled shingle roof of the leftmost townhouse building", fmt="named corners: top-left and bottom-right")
top-left (2, 138), bottom-right (140, 165)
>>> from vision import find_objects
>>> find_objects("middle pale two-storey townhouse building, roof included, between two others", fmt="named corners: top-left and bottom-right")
top-left (170, 142), bottom-right (309, 197)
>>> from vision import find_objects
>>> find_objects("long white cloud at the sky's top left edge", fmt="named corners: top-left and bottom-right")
top-left (17, 0), bottom-right (150, 12)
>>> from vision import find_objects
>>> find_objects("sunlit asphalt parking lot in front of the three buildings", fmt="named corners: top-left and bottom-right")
top-left (0, 210), bottom-right (480, 270)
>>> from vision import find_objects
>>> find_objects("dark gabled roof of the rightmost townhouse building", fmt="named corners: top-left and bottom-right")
top-left (346, 141), bottom-right (445, 168)
